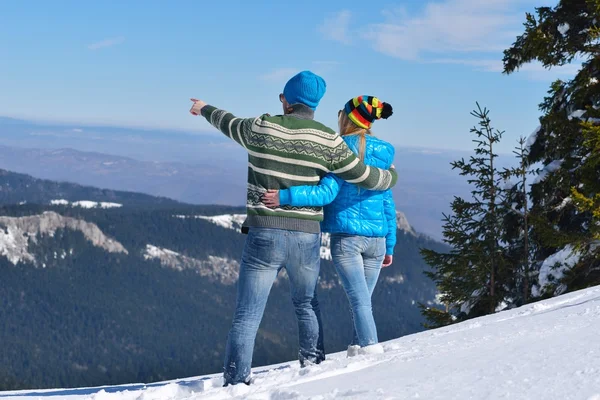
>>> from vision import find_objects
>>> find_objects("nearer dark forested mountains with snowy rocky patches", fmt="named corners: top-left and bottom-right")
top-left (0, 167), bottom-right (447, 389)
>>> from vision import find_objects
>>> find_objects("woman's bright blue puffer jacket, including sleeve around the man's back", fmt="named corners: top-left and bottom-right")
top-left (279, 135), bottom-right (396, 255)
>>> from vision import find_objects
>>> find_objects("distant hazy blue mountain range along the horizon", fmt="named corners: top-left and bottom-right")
top-left (0, 117), bottom-right (514, 239)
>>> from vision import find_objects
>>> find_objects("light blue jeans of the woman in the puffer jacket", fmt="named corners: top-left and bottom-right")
top-left (331, 234), bottom-right (385, 347)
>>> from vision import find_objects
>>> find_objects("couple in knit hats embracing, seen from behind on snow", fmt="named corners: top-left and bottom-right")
top-left (190, 71), bottom-right (397, 386)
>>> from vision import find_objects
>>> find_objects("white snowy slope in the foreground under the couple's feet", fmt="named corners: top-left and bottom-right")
top-left (0, 287), bottom-right (600, 400)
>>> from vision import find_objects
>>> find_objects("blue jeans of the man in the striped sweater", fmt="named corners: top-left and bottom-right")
top-left (224, 228), bottom-right (325, 385)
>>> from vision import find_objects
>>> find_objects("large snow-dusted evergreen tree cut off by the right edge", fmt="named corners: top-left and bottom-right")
top-left (504, 0), bottom-right (600, 295)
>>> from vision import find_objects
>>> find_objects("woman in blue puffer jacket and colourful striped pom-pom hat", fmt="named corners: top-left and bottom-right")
top-left (263, 96), bottom-right (396, 357)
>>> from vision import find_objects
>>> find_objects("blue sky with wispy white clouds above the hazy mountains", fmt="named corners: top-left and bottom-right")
top-left (0, 0), bottom-right (576, 152)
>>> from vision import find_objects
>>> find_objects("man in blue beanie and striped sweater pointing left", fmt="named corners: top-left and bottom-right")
top-left (190, 71), bottom-right (397, 386)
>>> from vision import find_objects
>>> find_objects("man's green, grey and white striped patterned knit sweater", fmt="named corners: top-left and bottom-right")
top-left (202, 104), bottom-right (398, 233)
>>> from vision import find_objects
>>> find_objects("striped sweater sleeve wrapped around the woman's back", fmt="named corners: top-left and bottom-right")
top-left (330, 137), bottom-right (398, 190)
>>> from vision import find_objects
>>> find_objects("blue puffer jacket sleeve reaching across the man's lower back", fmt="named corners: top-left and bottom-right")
top-left (279, 174), bottom-right (342, 207)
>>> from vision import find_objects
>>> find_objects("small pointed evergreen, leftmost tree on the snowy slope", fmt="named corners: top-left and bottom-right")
top-left (421, 104), bottom-right (508, 327)
